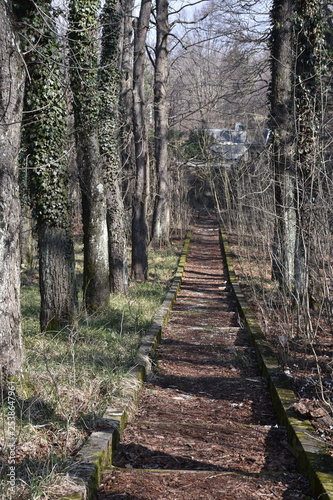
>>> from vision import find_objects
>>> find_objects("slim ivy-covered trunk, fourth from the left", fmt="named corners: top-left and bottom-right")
top-left (99, 0), bottom-right (128, 293)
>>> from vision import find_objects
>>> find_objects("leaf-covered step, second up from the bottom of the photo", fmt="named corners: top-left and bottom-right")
top-left (113, 420), bottom-right (296, 473)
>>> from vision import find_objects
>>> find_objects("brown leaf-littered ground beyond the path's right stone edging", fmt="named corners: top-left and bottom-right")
top-left (226, 230), bottom-right (333, 455)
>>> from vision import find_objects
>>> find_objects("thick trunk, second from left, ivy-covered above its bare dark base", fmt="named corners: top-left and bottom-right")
top-left (19, 0), bottom-right (77, 330)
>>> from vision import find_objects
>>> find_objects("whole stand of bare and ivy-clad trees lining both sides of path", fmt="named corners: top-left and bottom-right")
top-left (0, 0), bottom-right (333, 382)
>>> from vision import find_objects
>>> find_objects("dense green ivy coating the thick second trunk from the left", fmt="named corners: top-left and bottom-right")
top-left (16, 0), bottom-right (70, 227)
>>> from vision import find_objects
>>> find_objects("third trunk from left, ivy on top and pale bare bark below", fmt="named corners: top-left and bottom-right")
top-left (68, 0), bottom-right (110, 311)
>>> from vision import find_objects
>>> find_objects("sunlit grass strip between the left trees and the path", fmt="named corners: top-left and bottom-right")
top-left (0, 241), bottom-right (177, 500)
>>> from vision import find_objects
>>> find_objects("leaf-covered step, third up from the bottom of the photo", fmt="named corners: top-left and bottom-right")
top-left (136, 375), bottom-right (276, 425)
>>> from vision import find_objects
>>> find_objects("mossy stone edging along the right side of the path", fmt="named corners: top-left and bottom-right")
top-left (220, 228), bottom-right (333, 500)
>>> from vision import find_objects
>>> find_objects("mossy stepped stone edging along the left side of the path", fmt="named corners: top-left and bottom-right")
top-left (57, 230), bottom-right (192, 500)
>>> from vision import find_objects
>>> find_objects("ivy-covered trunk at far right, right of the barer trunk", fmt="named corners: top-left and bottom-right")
top-left (295, 0), bottom-right (325, 318)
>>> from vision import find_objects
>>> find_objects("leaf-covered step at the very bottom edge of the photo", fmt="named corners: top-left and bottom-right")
top-left (99, 468), bottom-right (312, 500)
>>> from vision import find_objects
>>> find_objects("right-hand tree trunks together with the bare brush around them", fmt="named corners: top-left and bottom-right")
top-left (209, 0), bottom-right (332, 341)
